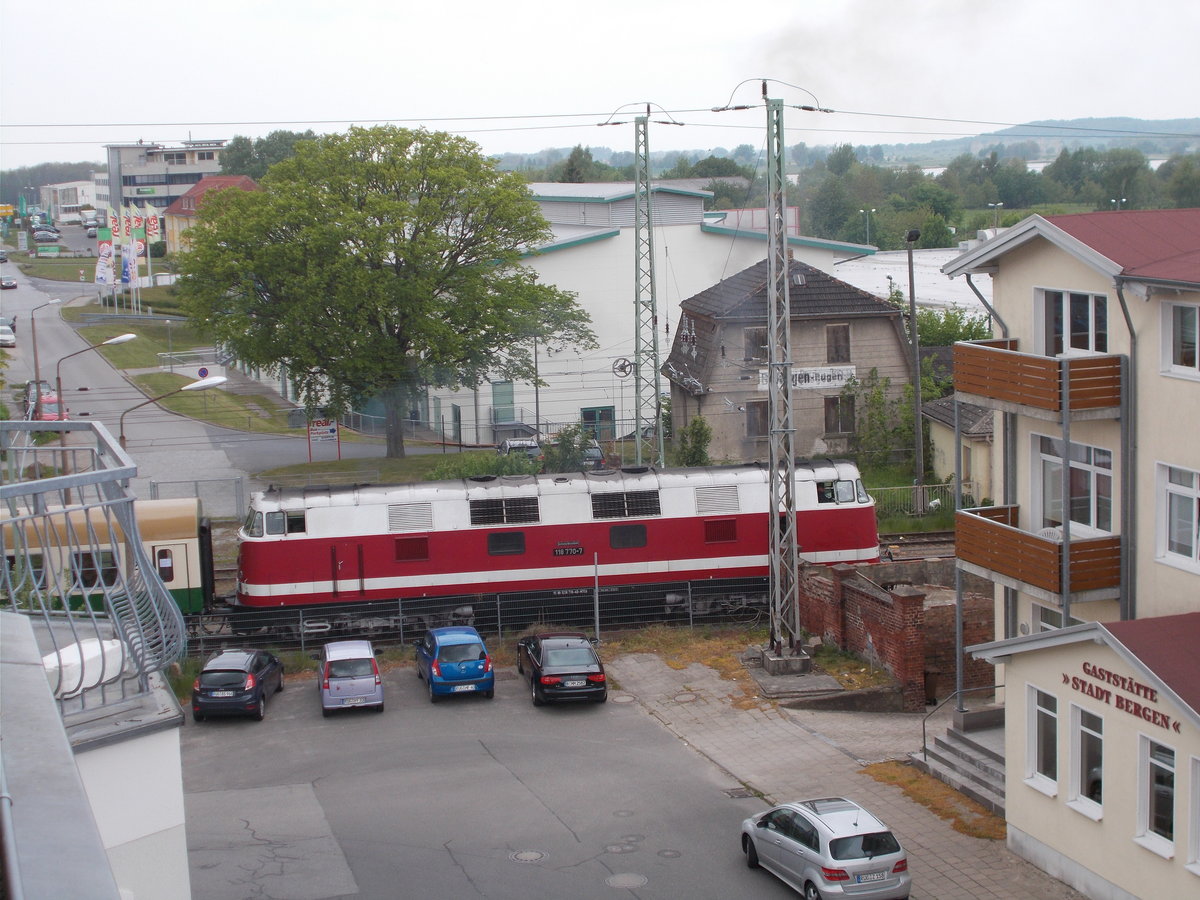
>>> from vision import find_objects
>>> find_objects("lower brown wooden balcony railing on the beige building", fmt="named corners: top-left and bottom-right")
top-left (955, 506), bottom-right (1121, 600)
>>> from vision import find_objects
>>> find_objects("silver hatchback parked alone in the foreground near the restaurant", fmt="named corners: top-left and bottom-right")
top-left (742, 797), bottom-right (912, 900)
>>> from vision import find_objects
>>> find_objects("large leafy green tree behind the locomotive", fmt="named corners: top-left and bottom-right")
top-left (180, 126), bottom-right (595, 456)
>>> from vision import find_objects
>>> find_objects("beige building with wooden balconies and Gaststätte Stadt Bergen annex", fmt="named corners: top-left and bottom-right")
top-left (943, 209), bottom-right (1200, 898)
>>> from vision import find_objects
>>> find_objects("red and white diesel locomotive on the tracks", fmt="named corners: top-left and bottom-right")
top-left (235, 461), bottom-right (878, 628)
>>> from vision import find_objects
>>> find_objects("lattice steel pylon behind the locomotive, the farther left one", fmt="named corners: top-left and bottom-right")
top-left (634, 109), bottom-right (664, 466)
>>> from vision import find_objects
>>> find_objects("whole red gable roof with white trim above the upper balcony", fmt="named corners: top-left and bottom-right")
top-left (942, 209), bottom-right (1200, 289)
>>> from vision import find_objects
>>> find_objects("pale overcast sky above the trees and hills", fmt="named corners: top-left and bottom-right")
top-left (0, 0), bottom-right (1200, 169)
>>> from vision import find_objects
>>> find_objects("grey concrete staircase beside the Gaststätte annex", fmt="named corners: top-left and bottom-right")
top-left (910, 709), bottom-right (1004, 817)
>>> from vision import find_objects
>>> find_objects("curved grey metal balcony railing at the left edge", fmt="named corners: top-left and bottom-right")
top-left (0, 421), bottom-right (186, 713)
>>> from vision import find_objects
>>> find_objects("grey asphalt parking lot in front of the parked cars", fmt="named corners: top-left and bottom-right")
top-left (181, 666), bottom-right (794, 900)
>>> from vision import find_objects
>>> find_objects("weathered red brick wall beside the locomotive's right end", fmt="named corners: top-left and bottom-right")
top-left (797, 563), bottom-right (994, 712)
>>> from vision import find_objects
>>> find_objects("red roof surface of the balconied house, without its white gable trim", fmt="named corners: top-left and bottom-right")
top-left (1046, 209), bottom-right (1200, 283)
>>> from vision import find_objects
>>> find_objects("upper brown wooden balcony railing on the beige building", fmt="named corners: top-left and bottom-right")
top-left (954, 341), bottom-right (1123, 414)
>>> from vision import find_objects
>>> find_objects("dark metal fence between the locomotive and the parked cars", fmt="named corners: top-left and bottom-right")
top-left (186, 578), bottom-right (769, 656)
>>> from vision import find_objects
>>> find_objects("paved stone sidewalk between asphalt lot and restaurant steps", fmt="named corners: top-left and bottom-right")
top-left (605, 654), bottom-right (1082, 900)
